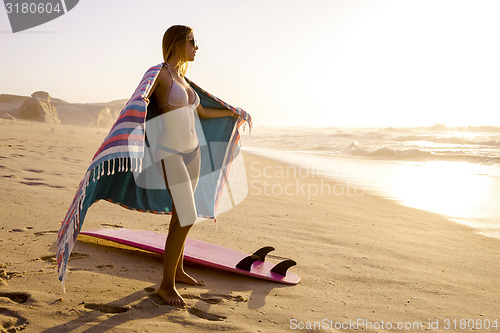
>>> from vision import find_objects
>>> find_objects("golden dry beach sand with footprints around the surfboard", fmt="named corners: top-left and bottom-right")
top-left (0, 119), bottom-right (500, 332)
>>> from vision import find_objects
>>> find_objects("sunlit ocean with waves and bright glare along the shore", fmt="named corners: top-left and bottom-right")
top-left (241, 125), bottom-right (500, 239)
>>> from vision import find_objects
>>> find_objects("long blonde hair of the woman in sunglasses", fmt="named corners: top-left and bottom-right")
top-left (162, 25), bottom-right (193, 76)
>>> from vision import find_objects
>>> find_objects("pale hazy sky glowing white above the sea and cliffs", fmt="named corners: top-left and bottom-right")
top-left (0, 0), bottom-right (500, 126)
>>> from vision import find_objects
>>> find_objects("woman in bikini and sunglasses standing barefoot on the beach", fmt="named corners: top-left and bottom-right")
top-left (148, 25), bottom-right (234, 307)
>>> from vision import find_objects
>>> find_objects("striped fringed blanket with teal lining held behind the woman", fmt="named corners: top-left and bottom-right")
top-left (57, 64), bottom-right (252, 285)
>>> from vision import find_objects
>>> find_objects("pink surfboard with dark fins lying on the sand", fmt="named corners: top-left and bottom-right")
top-left (80, 228), bottom-right (300, 285)
